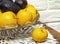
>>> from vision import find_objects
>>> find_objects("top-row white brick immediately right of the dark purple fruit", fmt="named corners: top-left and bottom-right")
top-left (27, 0), bottom-right (48, 10)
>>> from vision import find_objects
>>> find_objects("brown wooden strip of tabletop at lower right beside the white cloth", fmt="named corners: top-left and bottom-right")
top-left (46, 25), bottom-right (60, 44)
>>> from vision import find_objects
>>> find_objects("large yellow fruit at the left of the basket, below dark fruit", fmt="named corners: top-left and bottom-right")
top-left (0, 11), bottom-right (16, 28)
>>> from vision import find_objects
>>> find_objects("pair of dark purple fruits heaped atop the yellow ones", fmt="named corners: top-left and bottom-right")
top-left (0, 0), bottom-right (27, 13)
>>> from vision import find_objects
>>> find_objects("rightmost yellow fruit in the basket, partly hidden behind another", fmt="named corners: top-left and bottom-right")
top-left (26, 4), bottom-right (39, 21)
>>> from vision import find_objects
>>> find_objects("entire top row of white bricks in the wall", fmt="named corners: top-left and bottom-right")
top-left (27, 0), bottom-right (60, 10)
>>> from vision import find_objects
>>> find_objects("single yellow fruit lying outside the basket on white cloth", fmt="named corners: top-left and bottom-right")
top-left (32, 28), bottom-right (48, 42)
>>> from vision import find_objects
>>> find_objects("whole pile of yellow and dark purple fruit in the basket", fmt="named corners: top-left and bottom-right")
top-left (0, 0), bottom-right (39, 28)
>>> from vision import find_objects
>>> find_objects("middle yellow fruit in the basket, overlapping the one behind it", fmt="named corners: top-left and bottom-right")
top-left (17, 9), bottom-right (32, 26)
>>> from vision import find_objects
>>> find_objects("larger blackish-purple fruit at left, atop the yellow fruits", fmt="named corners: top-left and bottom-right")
top-left (0, 0), bottom-right (21, 13)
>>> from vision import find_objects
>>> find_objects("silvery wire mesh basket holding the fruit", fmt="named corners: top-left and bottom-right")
top-left (0, 17), bottom-right (38, 39)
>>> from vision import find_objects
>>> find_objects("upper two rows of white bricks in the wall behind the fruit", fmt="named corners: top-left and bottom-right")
top-left (27, 0), bottom-right (60, 22)
